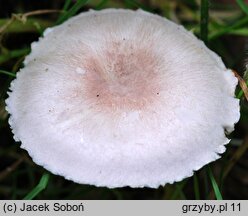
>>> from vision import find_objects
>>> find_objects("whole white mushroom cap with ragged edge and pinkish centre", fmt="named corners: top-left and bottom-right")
top-left (6, 9), bottom-right (240, 188)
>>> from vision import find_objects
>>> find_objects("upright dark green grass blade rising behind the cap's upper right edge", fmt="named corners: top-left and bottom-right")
top-left (200, 0), bottom-right (209, 44)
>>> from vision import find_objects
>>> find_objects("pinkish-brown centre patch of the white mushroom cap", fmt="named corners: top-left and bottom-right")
top-left (78, 40), bottom-right (163, 111)
